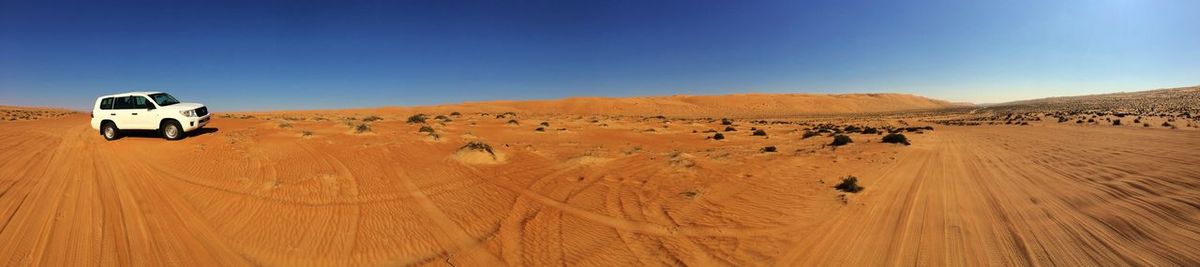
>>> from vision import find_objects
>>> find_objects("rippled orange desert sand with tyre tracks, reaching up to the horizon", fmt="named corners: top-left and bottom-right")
top-left (0, 91), bottom-right (1200, 266)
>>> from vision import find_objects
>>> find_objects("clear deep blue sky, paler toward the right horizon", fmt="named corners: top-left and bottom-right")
top-left (0, 0), bottom-right (1200, 111)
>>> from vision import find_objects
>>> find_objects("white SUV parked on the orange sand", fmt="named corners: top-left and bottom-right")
top-left (91, 91), bottom-right (209, 141)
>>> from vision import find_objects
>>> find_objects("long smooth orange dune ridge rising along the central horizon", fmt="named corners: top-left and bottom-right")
top-left (384, 94), bottom-right (962, 117)
